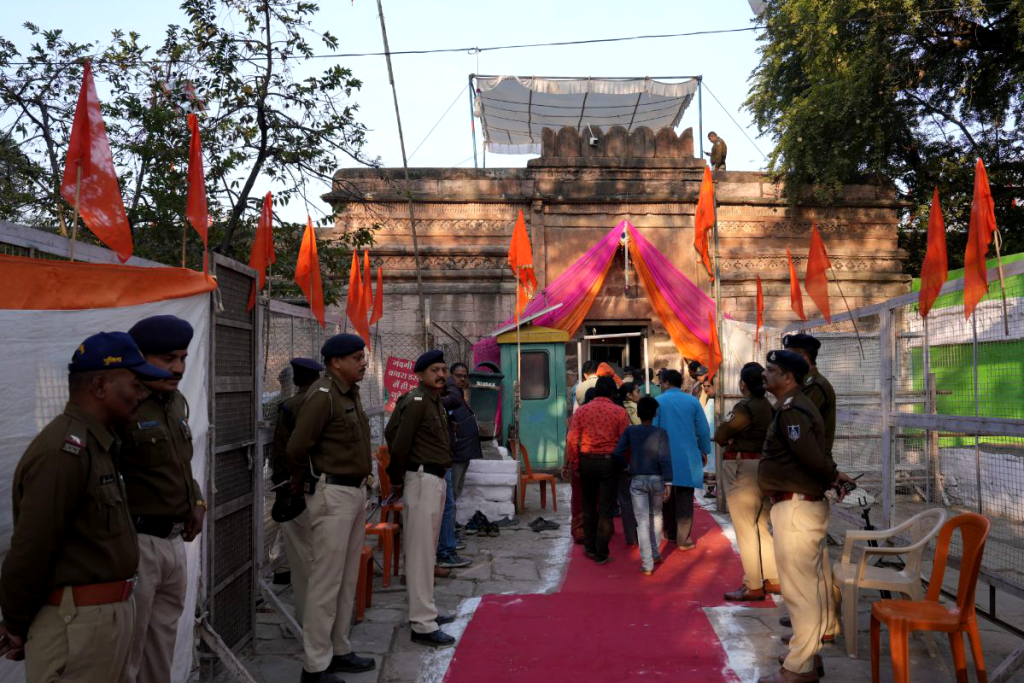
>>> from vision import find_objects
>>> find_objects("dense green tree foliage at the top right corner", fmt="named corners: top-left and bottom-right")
top-left (745, 0), bottom-right (1024, 273)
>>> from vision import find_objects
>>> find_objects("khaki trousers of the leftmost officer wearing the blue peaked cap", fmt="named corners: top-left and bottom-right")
top-left (25, 588), bottom-right (135, 683)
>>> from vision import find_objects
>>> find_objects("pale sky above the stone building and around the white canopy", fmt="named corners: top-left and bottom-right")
top-left (0, 0), bottom-right (772, 220)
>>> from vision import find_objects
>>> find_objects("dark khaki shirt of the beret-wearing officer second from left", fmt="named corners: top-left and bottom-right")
top-left (119, 391), bottom-right (203, 522)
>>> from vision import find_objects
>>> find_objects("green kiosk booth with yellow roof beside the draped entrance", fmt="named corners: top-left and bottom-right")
top-left (498, 325), bottom-right (569, 470)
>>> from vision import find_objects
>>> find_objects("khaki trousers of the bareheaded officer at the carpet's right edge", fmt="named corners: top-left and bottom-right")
top-left (721, 458), bottom-right (778, 591)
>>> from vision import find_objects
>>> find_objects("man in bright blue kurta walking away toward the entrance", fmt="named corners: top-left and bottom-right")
top-left (653, 370), bottom-right (712, 550)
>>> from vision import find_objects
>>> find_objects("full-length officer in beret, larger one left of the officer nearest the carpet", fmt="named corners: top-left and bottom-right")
top-left (287, 334), bottom-right (377, 683)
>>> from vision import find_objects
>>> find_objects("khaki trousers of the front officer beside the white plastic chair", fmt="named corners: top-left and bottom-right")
top-left (771, 500), bottom-right (836, 674)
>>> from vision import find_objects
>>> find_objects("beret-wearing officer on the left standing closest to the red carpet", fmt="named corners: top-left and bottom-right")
top-left (385, 350), bottom-right (455, 646)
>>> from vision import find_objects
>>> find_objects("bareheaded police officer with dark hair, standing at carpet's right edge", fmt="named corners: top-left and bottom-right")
top-left (715, 362), bottom-right (779, 601)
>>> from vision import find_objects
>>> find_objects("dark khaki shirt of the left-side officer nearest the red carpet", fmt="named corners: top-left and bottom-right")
top-left (384, 387), bottom-right (452, 482)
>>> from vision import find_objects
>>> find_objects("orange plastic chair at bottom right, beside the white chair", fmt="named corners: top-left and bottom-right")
top-left (871, 512), bottom-right (991, 683)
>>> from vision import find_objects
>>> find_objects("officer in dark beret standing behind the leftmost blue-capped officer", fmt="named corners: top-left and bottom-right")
top-left (120, 315), bottom-right (206, 683)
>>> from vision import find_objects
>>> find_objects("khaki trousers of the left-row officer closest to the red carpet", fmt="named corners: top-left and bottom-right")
top-left (401, 467), bottom-right (445, 633)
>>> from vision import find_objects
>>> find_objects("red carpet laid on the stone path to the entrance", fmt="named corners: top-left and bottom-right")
top-left (444, 508), bottom-right (772, 683)
